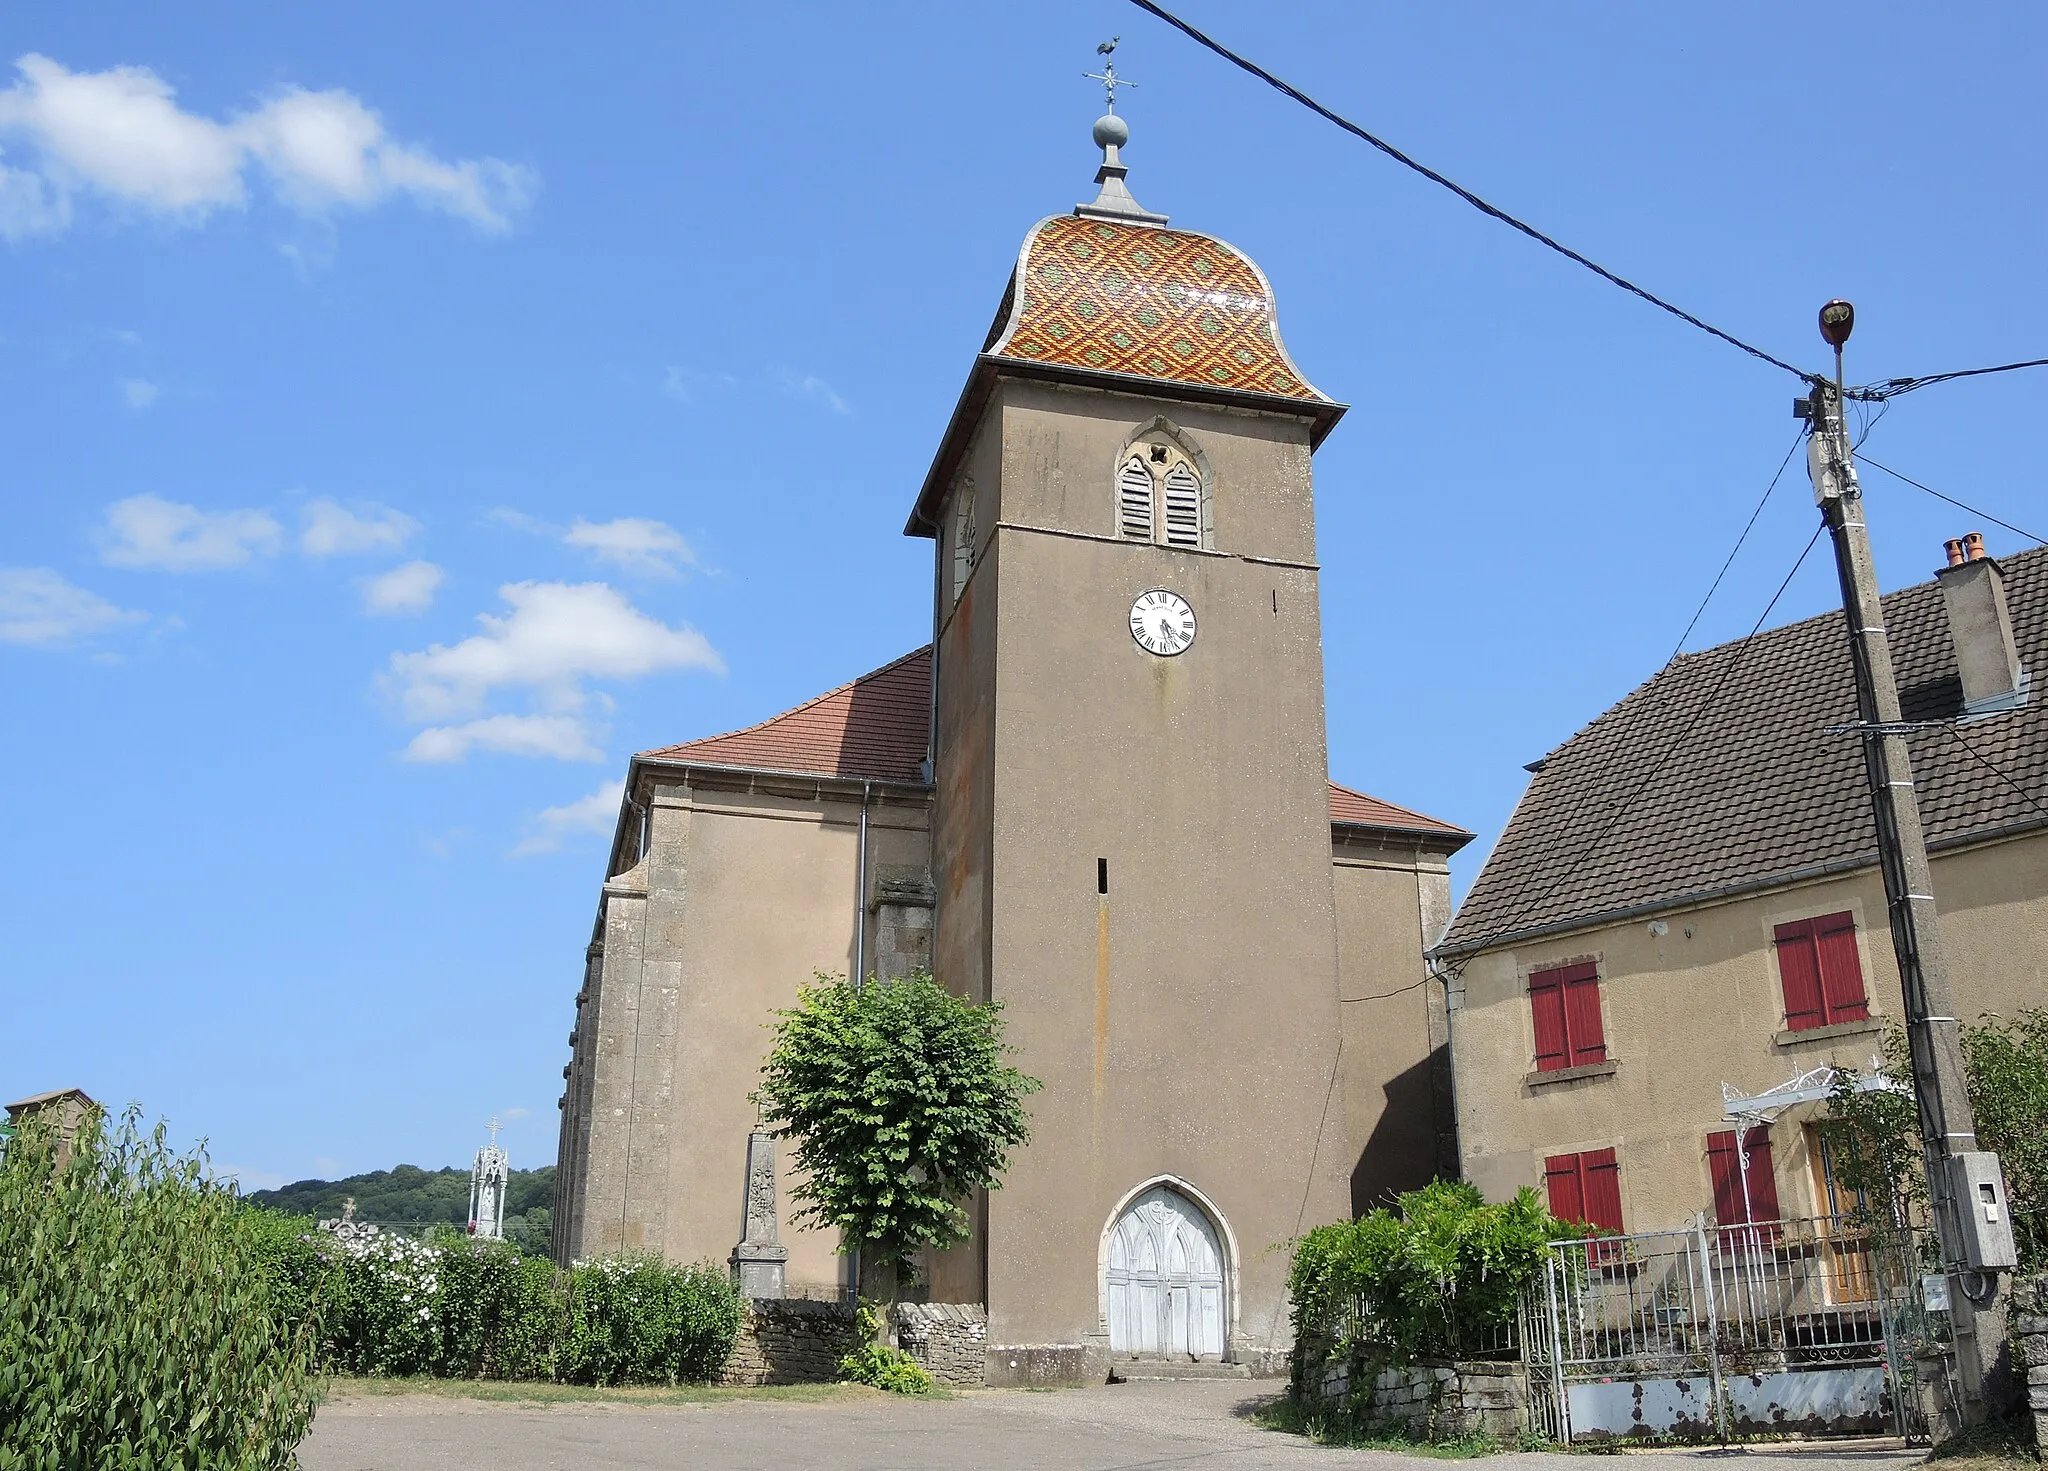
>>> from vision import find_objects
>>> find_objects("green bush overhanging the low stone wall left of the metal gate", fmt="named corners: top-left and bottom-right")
top-left (1288, 1180), bottom-right (1585, 1362)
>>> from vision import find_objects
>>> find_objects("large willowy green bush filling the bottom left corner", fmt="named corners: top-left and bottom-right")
top-left (0, 1108), bottom-right (313, 1471)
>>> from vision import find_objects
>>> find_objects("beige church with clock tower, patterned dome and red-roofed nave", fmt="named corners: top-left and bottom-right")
top-left (555, 113), bottom-right (1473, 1385)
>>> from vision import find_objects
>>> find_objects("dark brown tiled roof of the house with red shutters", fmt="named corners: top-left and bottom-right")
top-left (1440, 547), bottom-right (2048, 955)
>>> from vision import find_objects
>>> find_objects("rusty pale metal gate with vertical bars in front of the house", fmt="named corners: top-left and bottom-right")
top-left (1522, 1217), bottom-right (1929, 1442)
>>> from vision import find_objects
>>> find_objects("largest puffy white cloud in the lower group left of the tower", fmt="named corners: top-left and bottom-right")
top-left (387, 582), bottom-right (725, 721)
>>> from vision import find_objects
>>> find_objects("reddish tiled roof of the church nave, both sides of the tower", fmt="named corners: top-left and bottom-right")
top-left (639, 643), bottom-right (1473, 842)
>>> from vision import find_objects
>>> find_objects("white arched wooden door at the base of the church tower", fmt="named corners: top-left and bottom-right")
top-left (1104, 1184), bottom-right (1223, 1358)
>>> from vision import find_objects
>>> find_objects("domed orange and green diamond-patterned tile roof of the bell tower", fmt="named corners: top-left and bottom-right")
top-left (987, 215), bottom-right (1331, 404)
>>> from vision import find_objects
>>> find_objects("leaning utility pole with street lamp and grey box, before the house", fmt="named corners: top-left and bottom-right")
top-left (1800, 301), bottom-right (2017, 1426)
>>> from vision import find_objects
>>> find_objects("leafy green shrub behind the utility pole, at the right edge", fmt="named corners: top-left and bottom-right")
top-left (1821, 1008), bottom-right (2048, 1270)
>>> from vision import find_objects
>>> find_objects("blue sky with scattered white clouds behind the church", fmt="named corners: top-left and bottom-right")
top-left (0, 0), bottom-right (2048, 1184)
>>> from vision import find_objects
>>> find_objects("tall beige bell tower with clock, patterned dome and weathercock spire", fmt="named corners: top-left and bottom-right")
top-left (905, 100), bottom-right (1350, 1383)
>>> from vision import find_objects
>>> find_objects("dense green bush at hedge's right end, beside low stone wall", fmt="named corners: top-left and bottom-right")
top-left (555, 1256), bottom-right (743, 1385)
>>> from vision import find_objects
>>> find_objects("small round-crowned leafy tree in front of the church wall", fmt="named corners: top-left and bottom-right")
top-left (760, 975), bottom-right (1042, 1283)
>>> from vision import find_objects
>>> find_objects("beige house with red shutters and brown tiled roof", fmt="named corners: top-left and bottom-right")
top-left (1432, 537), bottom-right (2048, 1231)
